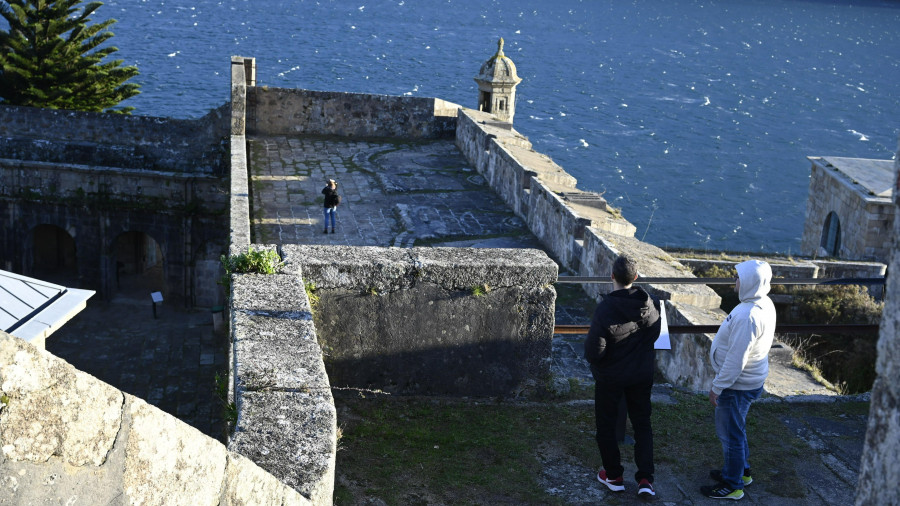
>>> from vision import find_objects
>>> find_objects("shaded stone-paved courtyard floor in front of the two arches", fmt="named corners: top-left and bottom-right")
top-left (46, 291), bottom-right (228, 441)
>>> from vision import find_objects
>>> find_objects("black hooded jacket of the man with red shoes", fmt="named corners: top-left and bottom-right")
top-left (584, 287), bottom-right (661, 383)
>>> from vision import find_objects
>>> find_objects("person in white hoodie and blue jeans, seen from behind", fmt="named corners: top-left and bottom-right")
top-left (700, 260), bottom-right (775, 500)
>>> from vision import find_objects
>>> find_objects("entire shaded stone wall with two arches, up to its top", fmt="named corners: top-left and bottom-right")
top-left (0, 104), bottom-right (230, 307)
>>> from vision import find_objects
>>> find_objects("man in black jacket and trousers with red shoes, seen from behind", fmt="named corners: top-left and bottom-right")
top-left (584, 255), bottom-right (660, 496)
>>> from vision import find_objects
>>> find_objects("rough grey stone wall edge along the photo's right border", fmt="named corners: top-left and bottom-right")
top-left (856, 140), bottom-right (900, 506)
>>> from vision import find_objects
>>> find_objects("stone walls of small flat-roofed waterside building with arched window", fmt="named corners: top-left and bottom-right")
top-left (801, 161), bottom-right (896, 262)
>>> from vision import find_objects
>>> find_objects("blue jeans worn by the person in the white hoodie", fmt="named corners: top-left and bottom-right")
top-left (716, 387), bottom-right (763, 490)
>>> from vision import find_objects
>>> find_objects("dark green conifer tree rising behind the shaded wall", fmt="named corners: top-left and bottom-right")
top-left (0, 0), bottom-right (140, 113)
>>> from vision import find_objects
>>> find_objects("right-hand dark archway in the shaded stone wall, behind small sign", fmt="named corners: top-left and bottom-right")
top-left (113, 231), bottom-right (166, 297)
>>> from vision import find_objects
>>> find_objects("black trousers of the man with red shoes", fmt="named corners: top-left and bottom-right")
top-left (594, 379), bottom-right (654, 483)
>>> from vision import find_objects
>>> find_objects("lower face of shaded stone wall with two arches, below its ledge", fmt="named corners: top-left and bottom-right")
top-left (0, 159), bottom-right (228, 307)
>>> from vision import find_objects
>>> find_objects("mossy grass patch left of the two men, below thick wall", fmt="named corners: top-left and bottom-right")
top-left (335, 398), bottom-right (593, 504)
